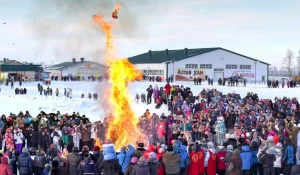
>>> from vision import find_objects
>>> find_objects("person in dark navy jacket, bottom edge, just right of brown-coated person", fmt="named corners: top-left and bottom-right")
top-left (78, 153), bottom-right (98, 175)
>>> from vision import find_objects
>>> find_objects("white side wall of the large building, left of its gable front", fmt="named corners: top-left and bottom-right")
top-left (136, 63), bottom-right (167, 78)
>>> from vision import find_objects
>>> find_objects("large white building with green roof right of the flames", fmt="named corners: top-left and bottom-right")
top-left (129, 47), bottom-right (270, 82)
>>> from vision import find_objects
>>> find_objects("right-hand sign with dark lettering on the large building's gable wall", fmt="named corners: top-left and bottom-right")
top-left (224, 69), bottom-right (262, 81)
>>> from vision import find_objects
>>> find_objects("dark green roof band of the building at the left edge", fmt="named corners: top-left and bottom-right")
top-left (0, 64), bottom-right (43, 72)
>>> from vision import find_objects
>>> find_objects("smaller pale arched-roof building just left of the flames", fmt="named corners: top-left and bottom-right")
top-left (45, 58), bottom-right (108, 80)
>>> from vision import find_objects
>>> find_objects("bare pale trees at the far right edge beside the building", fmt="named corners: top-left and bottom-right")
top-left (282, 49), bottom-right (300, 78)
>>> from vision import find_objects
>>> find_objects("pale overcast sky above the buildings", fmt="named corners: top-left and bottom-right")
top-left (0, 0), bottom-right (300, 67)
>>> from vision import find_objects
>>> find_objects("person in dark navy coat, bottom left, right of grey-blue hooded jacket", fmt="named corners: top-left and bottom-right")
top-left (33, 149), bottom-right (46, 175)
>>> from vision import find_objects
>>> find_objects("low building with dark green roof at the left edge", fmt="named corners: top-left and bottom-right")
top-left (0, 58), bottom-right (43, 82)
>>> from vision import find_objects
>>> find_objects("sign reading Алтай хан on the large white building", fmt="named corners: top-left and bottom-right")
top-left (175, 68), bottom-right (205, 81)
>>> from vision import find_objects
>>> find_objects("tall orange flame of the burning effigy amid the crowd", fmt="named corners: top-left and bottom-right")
top-left (94, 15), bottom-right (144, 148)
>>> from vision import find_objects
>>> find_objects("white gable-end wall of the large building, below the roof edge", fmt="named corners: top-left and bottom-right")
top-left (168, 49), bottom-right (268, 82)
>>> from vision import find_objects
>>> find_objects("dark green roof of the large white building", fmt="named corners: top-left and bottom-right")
top-left (128, 47), bottom-right (270, 65)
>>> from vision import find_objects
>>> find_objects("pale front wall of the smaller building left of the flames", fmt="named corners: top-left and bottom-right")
top-left (61, 62), bottom-right (107, 78)
